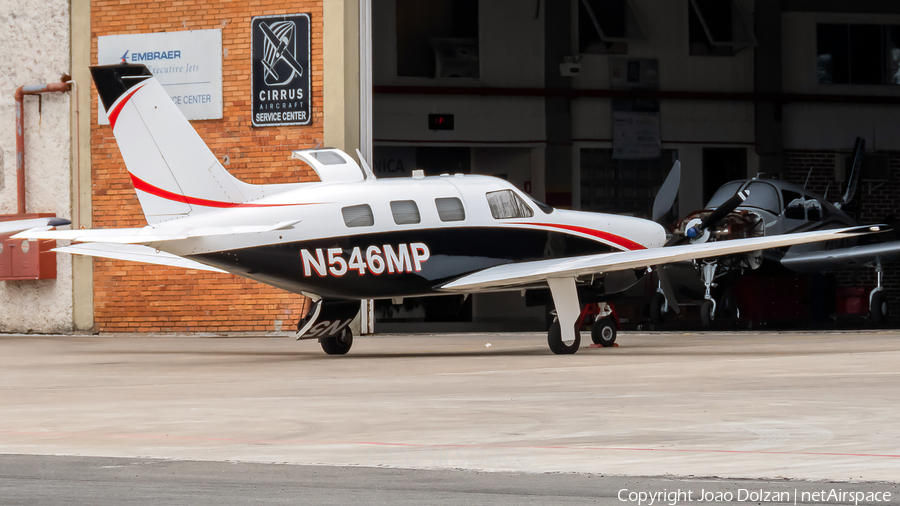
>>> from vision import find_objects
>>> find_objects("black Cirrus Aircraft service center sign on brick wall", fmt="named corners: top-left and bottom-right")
top-left (250, 14), bottom-right (312, 126)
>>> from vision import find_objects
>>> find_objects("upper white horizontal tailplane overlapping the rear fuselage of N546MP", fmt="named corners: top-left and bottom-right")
top-left (13, 220), bottom-right (300, 244)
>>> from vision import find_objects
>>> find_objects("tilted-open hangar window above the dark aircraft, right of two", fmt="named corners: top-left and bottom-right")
top-left (688, 0), bottom-right (756, 56)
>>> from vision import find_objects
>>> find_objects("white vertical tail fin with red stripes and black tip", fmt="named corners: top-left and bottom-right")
top-left (91, 63), bottom-right (262, 224)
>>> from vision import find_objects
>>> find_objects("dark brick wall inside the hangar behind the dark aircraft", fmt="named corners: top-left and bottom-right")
top-left (784, 151), bottom-right (900, 325)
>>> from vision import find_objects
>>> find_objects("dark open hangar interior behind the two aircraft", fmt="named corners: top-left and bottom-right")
top-left (372, 0), bottom-right (900, 332)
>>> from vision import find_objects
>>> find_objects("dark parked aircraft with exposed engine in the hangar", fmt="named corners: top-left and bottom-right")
top-left (650, 139), bottom-right (900, 326)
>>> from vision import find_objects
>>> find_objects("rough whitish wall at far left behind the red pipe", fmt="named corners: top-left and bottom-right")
top-left (0, 0), bottom-right (72, 332)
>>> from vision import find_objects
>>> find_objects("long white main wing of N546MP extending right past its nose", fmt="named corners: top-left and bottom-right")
top-left (440, 226), bottom-right (887, 293)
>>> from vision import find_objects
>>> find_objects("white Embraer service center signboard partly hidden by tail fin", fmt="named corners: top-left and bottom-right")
top-left (97, 30), bottom-right (222, 124)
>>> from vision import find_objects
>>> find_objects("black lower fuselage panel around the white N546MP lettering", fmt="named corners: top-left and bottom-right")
top-left (189, 227), bottom-right (620, 299)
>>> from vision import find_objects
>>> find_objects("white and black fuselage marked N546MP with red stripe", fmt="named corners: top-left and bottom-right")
top-left (158, 175), bottom-right (665, 299)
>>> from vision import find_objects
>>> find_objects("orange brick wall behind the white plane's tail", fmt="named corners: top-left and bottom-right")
top-left (91, 0), bottom-right (323, 332)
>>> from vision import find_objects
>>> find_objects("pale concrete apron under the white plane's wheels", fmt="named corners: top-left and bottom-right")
top-left (0, 331), bottom-right (900, 481)
